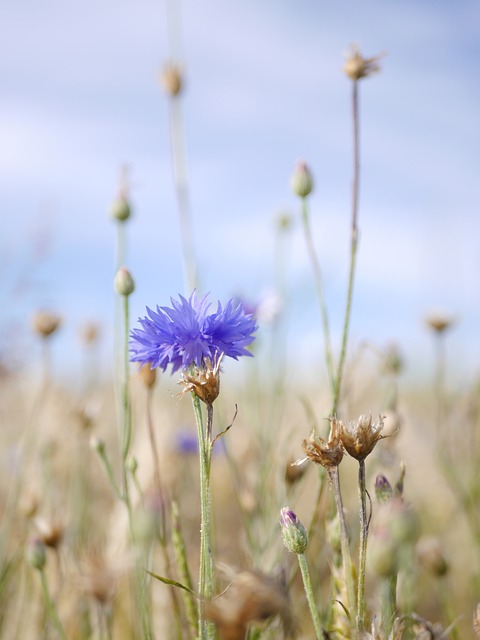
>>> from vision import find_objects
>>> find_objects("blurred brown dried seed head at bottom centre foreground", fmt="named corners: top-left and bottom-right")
top-left (205, 571), bottom-right (291, 640)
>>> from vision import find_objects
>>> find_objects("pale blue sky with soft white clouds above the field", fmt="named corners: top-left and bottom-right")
top-left (0, 0), bottom-right (480, 384)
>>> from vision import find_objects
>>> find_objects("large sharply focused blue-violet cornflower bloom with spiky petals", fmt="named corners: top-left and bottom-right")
top-left (130, 291), bottom-right (257, 373)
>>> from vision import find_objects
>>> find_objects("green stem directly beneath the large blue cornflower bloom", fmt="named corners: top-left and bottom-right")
top-left (192, 392), bottom-right (213, 640)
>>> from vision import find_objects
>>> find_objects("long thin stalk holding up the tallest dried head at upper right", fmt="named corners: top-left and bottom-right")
top-left (332, 80), bottom-right (360, 415)
